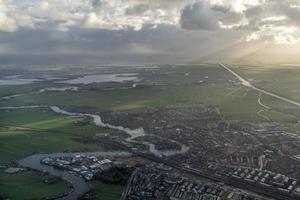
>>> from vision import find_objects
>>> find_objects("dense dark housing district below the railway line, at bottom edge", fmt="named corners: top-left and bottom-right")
top-left (124, 164), bottom-right (265, 200)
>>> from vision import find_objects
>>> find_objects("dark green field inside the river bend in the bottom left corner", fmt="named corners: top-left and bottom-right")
top-left (0, 171), bottom-right (67, 200)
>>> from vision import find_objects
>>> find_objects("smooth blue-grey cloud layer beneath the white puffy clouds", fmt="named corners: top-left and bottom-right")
top-left (0, 25), bottom-right (244, 64)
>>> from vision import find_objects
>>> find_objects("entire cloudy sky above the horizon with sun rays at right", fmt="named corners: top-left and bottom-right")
top-left (0, 0), bottom-right (300, 65)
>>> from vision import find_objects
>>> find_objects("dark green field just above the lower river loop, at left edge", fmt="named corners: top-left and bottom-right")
top-left (0, 131), bottom-right (101, 165)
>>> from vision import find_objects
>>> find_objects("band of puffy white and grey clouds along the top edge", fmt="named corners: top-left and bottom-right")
top-left (0, 0), bottom-right (300, 31)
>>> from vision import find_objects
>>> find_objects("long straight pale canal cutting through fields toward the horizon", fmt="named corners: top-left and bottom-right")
top-left (219, 63), bottom-right (300, 106)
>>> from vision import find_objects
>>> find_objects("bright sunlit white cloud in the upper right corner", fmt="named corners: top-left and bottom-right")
top-left (241, 0), bottom-right (300, 44)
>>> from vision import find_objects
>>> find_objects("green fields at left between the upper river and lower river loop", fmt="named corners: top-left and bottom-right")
top-left (0, 109), bottom-right (124, 164)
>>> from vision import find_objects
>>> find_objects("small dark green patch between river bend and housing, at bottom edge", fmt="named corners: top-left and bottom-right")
top-left (91, 181), bottom-right (125, 200)
